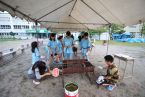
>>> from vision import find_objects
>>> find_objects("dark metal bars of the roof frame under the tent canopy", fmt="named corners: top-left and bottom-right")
top-left (0, 0), bottom-right (110, 28)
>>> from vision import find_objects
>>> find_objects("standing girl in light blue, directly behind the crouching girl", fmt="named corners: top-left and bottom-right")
top-left (31, 41), bottom-right (40, 65)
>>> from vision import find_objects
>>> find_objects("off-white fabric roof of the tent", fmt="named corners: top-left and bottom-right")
top-left (0, 0), bottom-right (145, 30)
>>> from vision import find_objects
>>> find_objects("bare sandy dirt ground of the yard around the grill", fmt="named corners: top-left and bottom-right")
top-left (0, 39), bottom-right (145, 97)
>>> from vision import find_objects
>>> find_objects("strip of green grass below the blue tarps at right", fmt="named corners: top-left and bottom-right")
top-left (95, 40), bottom-right (145, 47)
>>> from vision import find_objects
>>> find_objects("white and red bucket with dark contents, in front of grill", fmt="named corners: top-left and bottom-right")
top-left (65, 82), bottom-right (79, 97)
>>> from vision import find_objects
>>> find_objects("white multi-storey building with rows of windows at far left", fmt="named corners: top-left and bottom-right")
top-left (0, 11), bottom-right (35, 38)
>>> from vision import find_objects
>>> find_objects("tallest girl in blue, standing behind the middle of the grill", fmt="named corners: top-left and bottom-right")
top-left (63, 31), bottom-right (73, 59)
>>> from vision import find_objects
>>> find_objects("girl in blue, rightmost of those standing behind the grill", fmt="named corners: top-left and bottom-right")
top-left (80, 32), bottom-right (90, 58)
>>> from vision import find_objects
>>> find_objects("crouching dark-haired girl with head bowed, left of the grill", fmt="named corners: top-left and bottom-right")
top-left (28, 61), bottom-right (51, 85)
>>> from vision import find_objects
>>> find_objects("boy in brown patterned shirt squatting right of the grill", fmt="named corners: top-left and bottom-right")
top-left (97, 55), bottom-right (119, 88)
